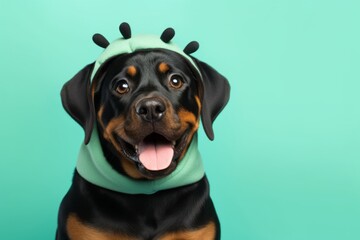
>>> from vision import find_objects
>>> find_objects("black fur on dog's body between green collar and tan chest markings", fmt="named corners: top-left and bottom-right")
top-left (57, 172), bottom-right (220, 240)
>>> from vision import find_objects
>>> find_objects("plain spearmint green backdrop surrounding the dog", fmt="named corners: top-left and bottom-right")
top-left (0, 0), bottom-right (360, 240)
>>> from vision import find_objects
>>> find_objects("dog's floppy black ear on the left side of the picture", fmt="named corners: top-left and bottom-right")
top-left (61, 63), bottom-right (95, 144)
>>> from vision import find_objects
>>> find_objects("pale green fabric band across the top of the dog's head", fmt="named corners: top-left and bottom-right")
top-left (91, 35), bottom-right (201, 79)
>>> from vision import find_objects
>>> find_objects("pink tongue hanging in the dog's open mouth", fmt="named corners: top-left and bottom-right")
top-left (139, 142), bottom-right (174, 171)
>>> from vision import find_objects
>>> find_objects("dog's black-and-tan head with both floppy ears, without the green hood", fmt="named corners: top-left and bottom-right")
top-left (61, 23), bottom-right (230, 179)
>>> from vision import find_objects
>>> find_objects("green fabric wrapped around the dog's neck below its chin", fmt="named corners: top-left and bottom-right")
top-left (76, 128), bottom-right (205, 194)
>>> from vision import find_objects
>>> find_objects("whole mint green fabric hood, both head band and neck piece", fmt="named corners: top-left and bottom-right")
top-left (76, 35), bottom-right (204, 194)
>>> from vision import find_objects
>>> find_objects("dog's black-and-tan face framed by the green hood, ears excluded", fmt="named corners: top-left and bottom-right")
top-left (93, 50), bottom-right (201, 178)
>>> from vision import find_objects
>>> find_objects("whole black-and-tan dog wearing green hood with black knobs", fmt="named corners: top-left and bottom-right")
top-left (56, 23), bottom-right (230, 240)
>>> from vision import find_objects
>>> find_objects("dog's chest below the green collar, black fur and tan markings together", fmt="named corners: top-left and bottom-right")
top-left (66, 175), bottom-right (211, 240)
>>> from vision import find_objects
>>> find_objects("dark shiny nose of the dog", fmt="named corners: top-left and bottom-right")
top-left (135, 98), bottom-right (166, 122)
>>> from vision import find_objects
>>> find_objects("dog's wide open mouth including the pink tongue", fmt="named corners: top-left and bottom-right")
top-left (117, 132), bottom-right (187, 175)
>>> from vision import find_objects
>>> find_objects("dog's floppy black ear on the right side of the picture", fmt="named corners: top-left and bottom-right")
top-left (193, 58), bottom-right (230, 140)
